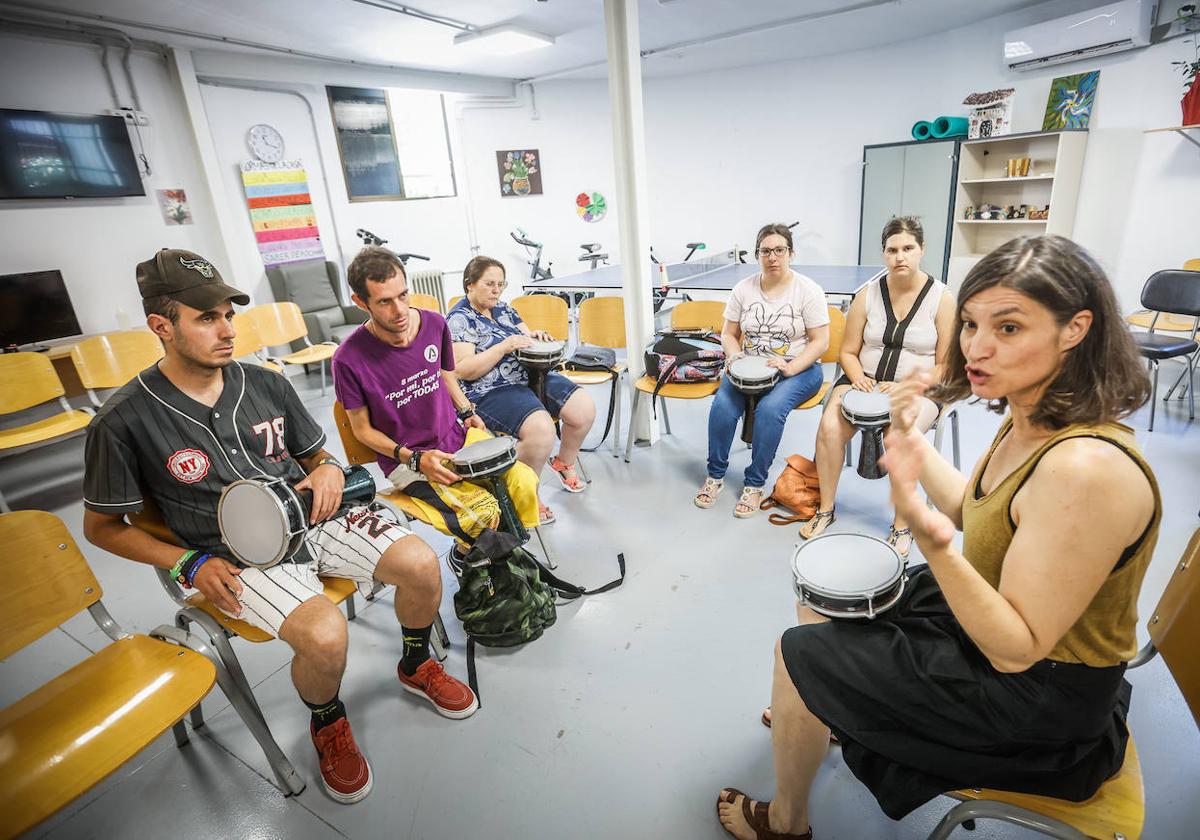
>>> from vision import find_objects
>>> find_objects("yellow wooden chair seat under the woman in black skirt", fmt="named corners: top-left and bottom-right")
top-left (947, 737), bottom-right (1146, 840)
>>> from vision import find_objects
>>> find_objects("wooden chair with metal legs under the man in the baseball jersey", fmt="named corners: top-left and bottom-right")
top-left (127, 499), bottom-right (424, 796)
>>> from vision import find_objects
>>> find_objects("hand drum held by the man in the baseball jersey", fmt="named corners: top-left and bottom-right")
top-left (217, 464), bottom-right (374, 569)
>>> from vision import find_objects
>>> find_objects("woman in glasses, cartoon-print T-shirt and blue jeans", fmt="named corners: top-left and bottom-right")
top-left (695, 224), bottom-right (829, 518)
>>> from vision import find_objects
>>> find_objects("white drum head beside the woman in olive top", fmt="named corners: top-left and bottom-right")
top-left (792, 534), bottom-right (904, 599)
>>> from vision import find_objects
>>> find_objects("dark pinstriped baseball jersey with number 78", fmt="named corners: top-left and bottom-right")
top-left (84, 362), bottom-right (325, 562)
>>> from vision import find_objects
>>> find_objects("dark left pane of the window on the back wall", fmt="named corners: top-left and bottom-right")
top-left (325, 85), bottom-right (404, 202)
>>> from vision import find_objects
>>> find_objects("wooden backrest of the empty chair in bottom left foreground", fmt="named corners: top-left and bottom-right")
top-left (0, 510), bottom-right (103, 659)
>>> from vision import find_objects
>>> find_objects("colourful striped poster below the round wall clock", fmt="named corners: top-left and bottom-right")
top-left (241, 161), bottom-right (325, 265)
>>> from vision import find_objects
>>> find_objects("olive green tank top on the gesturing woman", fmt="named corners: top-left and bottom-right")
top-left (962, 416), bottom-right (1163, 667)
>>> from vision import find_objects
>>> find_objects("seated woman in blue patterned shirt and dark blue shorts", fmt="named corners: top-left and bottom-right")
top-left (446, 257), bottom-right (596, 524)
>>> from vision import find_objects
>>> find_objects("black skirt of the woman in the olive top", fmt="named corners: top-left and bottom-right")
top-left (782, 566), bottom-right (1130, 820)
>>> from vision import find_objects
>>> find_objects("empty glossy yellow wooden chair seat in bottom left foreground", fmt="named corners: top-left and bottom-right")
top-left (0, 636), bottom-right (216, 835)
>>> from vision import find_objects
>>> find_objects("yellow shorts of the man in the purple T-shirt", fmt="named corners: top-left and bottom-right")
top-left (391, 428), bottom-right (538, 547)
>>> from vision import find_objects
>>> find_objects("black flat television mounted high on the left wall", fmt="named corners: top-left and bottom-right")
top-left (0, 108), bottom-right (145, 198)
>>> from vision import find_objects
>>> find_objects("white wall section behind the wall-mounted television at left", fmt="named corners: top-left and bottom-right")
top-left (0, 36), bottom-right (218, 332)
